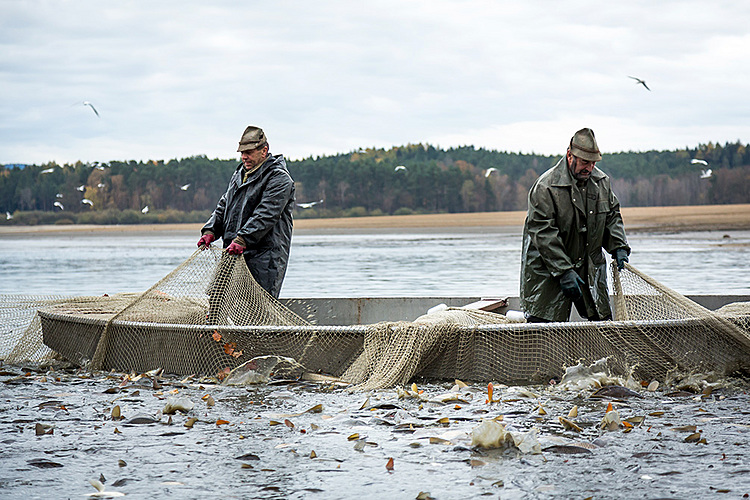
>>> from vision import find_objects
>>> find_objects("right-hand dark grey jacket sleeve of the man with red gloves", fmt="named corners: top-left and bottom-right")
top-left (237, 169), bottom-right (294, 247)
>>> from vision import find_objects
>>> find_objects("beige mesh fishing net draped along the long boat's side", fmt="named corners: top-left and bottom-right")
top-left (0, 247), bottom-right (750, 390)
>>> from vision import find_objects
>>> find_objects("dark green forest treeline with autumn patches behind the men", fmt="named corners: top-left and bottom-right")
top-left (0, 142), bottom-right (750, 224)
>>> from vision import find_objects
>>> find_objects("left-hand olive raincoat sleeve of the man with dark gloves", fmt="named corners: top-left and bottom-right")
top-left (527, 183), bottom-right (573, 277)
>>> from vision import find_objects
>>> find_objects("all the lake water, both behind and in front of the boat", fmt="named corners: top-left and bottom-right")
top-left (0, 229), bottom-right (750, 499)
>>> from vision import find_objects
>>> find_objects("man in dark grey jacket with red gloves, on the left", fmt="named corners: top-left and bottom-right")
top-left (198, 125), bottom-right (294, 298)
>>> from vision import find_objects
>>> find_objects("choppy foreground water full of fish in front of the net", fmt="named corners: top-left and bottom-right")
top-left (0, 367), bottom-right (750, 499)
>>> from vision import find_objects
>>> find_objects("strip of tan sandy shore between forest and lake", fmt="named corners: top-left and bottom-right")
top-left (0, 204), bottom-right (750, 236)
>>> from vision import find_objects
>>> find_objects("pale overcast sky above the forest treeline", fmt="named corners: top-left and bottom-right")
top-left (0, 0), bottom-right (750, 164)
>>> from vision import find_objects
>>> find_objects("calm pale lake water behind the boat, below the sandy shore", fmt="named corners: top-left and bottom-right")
top-left (0, 228), bottom-right (750, 297)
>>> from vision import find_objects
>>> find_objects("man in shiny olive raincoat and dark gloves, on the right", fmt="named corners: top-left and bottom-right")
top-left (521, 128), bottom-right (630, 322)
